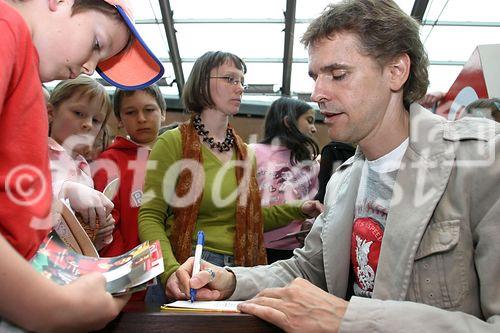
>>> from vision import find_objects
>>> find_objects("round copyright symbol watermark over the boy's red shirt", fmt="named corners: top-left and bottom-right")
top-left (5, 164), bottom-right (47, 206)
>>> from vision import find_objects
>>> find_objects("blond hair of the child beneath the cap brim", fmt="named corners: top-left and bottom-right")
top-left (49, 75), bottom-right (113, 135)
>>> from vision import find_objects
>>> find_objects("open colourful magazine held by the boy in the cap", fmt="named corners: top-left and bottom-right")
top-left (31, 232), bottom-right (164, 295)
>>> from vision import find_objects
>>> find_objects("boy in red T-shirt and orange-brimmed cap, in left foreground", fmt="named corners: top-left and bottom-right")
top-left (0, 0), bottom-right (163, 331)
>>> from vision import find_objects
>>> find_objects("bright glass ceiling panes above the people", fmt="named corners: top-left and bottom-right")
top-left (47, 0), bottom-right (500, 101)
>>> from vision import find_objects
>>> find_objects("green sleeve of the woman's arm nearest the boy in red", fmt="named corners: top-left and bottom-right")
top-left (138, 130), bottom-right (182, 284)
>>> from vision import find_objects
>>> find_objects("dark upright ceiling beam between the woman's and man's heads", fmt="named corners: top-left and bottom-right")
top-left (281, 0), bottom-right (297, 96)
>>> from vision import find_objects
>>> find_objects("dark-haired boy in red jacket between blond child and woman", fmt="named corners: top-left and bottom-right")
top-left (92, 85), bottom-right (166, 257)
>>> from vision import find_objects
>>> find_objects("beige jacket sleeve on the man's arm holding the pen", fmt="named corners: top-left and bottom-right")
top-left (226, 210), bottom-right (326, 300)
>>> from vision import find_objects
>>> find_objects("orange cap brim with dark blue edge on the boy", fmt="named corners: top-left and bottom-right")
top-left (96, 6), bottom-right (165, 90)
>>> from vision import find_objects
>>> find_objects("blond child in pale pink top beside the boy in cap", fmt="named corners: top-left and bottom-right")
top-left (47, 75), bottom-right (115, 250)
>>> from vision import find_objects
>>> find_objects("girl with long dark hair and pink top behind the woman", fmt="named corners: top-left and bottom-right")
top-left (250, 97), bottom-right (319, 263)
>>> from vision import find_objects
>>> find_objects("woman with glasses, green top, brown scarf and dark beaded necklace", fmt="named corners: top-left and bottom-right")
top-left (139, 51), bottom-right (322, 304)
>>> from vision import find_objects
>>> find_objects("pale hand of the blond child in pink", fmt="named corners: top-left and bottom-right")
top-left (62, 181), bottom-right (114, 229)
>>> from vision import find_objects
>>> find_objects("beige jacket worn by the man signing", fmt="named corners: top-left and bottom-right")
top-left (231, 104), bottom-right (500, 332)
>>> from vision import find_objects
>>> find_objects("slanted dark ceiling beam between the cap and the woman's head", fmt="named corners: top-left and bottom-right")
top-left (159, 0), bottom-right (185, 96)
